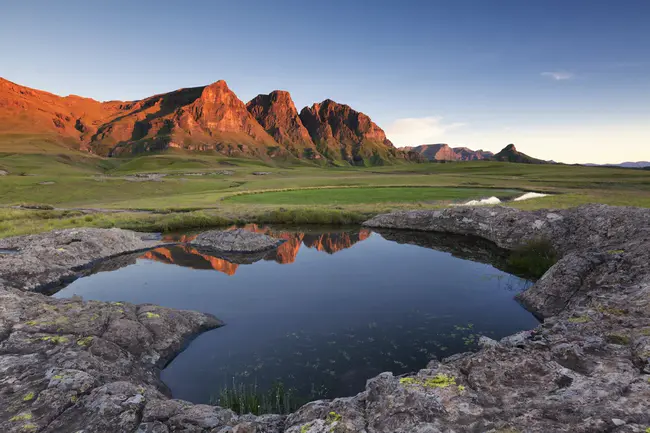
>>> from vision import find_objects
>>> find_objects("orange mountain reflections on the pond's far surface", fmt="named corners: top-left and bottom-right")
top-left (139, 224), bottom-right (371, 275)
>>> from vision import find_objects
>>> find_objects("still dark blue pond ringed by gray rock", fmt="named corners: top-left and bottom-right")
top-left (54, 226), bottom-right (538, 403)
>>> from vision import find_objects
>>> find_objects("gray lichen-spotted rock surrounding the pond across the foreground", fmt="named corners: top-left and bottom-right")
top-left (0, 206), bottom-right (650, 433)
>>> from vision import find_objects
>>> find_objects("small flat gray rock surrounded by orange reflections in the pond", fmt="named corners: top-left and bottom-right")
top-left (191, 229), bottom-right (283, 254)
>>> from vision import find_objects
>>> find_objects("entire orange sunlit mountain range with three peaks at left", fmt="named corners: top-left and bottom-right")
top-left (0, 78), bottom-right (394, 165)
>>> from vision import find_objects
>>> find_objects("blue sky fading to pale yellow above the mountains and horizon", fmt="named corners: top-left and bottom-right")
top-left (0, 0), bottom-right (650, 163)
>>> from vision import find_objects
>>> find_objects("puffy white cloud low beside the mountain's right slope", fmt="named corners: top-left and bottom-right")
top-left (386, 116), bottom-right (465, 146)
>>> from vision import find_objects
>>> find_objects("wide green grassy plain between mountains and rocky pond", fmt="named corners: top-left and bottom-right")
top-left (0, 148), bottom-right (650, 237)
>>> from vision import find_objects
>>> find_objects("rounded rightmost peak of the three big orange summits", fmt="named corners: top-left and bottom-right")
top-left (300, 99), bottom-right (404, 165)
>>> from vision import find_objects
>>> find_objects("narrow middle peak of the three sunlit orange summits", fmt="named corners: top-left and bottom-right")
top-left (246, 90), bottom-right (322, 159)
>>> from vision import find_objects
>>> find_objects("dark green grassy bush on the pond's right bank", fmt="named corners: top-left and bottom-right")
top-left (508, 239), bottom-right (557, 279)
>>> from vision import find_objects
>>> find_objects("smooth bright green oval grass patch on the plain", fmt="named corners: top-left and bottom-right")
top-left (227, 187), bottom-right (521, 206)
